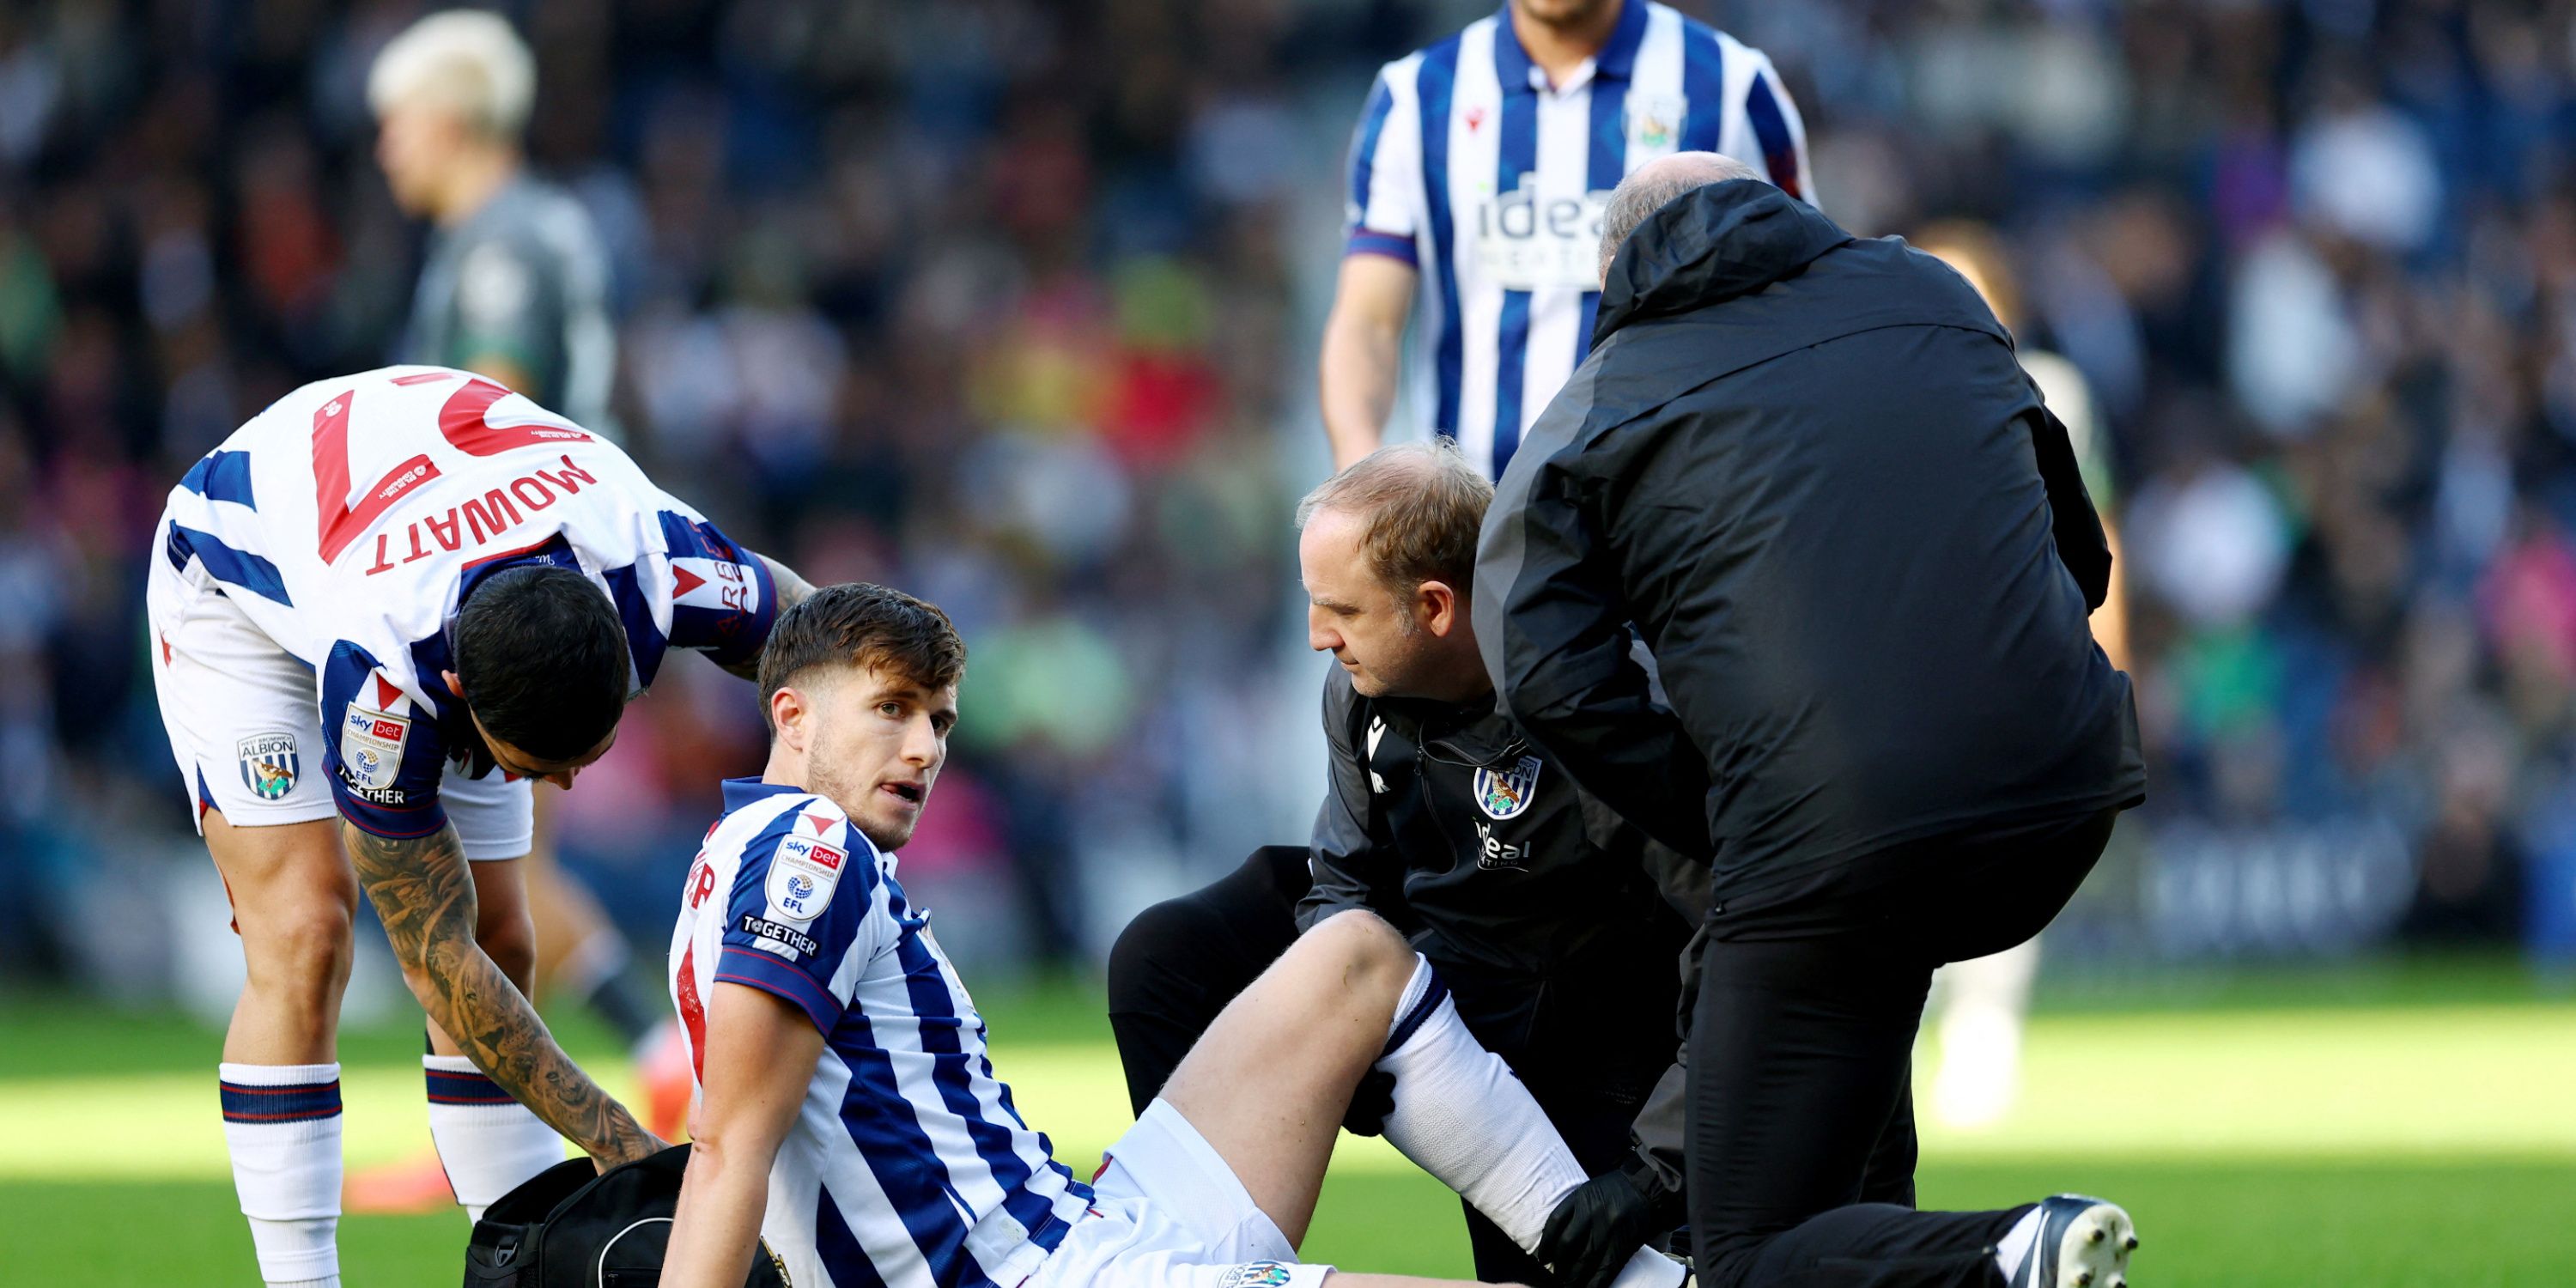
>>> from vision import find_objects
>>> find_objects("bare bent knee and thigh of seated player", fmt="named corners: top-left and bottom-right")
top-left (1162, 912), bottom-right (1414, 1247)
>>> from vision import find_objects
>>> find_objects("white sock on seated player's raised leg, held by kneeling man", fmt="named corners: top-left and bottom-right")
top-left (1378, 956), bottom-right (1682, 1288)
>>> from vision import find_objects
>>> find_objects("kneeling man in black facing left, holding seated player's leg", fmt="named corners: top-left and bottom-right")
top-left (1108, 438), bottom-right (1914, 1285)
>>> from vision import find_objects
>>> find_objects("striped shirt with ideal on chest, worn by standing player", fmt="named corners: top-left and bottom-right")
top-left (1350, 0), bottom-right (1814, 477)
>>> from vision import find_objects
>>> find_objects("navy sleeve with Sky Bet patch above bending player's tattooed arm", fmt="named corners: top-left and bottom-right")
top-left (322, 639), bottom-right (448, 840)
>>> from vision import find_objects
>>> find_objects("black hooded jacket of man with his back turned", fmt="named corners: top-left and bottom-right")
top-left (1473, 180), bottom-right (2146, 912)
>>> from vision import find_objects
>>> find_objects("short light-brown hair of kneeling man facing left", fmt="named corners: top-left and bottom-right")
top-left (1296, 438), bottom-right (1494, 600)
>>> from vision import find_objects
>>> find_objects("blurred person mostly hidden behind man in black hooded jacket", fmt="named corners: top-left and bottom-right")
top-left (1914, 219), bottom-right (2128, 1131)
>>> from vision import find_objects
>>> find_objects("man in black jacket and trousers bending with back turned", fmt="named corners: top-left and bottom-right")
top-left (1473, 152), bottom-right (2146, 1288)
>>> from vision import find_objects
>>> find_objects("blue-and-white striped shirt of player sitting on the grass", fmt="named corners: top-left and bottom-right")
top-left (670, 778), bottom-right (1092, 1288)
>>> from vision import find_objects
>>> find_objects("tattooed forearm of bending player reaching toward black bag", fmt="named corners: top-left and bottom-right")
top-left (340, 827), bottom-right (662, 1164)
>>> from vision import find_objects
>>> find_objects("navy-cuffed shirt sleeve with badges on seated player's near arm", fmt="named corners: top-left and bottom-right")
top-left (716, 796), bottom-right (891, 1033)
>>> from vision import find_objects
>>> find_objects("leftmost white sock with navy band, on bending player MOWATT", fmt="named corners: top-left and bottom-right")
top-left (216, 1064), bottom-right (340, 1288)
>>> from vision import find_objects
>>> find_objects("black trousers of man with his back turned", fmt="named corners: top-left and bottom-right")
top-left (1687, 811), bottom-right (2117, 1288)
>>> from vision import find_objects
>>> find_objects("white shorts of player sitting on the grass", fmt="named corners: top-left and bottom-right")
top-left (1023, 1100), bottom-right (1332, 1288)
